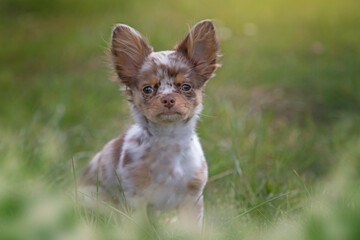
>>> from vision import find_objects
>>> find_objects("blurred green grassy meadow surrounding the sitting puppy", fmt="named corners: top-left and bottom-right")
top-left (0, 0), bottom-right (360, 239)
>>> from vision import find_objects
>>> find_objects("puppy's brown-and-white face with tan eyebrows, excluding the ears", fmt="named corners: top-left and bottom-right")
top-left (132, 51), bottom-right (203, 123)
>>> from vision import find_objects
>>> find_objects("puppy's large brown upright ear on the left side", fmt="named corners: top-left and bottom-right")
top-left (111, 24), bottom-right (152, 87)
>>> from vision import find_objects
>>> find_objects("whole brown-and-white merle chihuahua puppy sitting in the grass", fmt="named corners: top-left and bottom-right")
top-left (79, 20), bottom-right (219, 225)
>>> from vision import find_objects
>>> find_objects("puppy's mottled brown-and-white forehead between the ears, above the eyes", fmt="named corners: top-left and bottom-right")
top-left (139, 51), bottom-right (191, 81)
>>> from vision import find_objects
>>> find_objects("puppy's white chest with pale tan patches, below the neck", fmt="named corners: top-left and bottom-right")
top-left (121, 133), bottom-right (204, 210)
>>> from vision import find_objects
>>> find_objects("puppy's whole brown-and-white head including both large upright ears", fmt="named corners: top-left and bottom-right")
top-left (111, 21), bottom-right (218, 124)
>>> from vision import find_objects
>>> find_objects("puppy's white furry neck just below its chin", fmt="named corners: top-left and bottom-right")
top-left (131, 104), bottom-right (202, 140)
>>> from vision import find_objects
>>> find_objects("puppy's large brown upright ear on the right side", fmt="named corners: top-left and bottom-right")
top-left (175, 20), bottom-right (220, 82)
